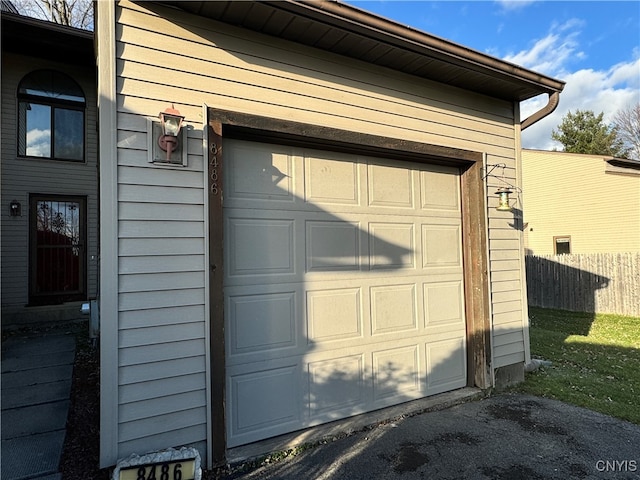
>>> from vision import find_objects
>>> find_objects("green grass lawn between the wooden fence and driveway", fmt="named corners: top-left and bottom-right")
top-left (516, 307), bottom-right (640, 425)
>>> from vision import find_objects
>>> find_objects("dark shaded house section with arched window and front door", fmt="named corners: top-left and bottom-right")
top-left (1, 11), bottom-right (98, 327)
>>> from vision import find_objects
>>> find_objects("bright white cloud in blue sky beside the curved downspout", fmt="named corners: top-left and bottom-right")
top-left (504, 20), bottom-right (640, 150)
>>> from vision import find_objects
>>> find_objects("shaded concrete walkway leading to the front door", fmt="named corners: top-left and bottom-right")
top-left (1, 333), bottom-right (76, 480)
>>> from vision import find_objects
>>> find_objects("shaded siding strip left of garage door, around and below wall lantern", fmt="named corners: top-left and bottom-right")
top-left (112, 108), bottom-right (207, 458)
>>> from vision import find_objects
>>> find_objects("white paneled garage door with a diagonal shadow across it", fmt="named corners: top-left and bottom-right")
top-left (224, 140), bottom-right (466, 447)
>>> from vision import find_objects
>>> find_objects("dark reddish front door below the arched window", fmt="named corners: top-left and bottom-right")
top-left (29, 195), bottom-right (87, 305)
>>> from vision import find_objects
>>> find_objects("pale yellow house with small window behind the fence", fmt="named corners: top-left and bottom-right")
top-left (522, 149), bottom-right (640, 255)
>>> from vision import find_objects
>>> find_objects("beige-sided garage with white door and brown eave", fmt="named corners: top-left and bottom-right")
top-left (96, 1), bottom-right (564, 466)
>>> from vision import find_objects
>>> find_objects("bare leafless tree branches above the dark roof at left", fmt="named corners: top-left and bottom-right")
top-left (13, 0), bottom-right (93, 30)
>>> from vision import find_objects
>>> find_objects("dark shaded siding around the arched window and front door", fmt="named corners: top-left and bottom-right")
top-left (1, 52), bottom-right (99, 312)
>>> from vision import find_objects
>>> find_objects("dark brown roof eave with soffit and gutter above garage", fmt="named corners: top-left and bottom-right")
top-left (158, 0), bottom-right (564, 101)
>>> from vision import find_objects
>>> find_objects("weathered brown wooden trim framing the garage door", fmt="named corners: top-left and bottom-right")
top-left (207, 108), bottom-right (491, 462)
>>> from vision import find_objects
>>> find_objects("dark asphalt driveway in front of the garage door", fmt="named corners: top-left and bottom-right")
top-left (229, 394), bottom-right (640, 480)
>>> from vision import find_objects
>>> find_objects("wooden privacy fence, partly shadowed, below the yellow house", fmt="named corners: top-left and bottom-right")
top-left (525, 253), bottom-right (640, 317)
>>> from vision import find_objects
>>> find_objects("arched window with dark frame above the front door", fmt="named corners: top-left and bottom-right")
top-left (18, 70), bottom-right (86, 161)
